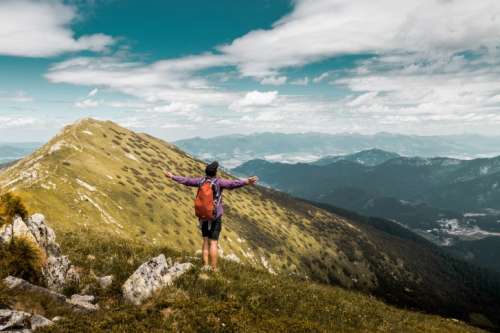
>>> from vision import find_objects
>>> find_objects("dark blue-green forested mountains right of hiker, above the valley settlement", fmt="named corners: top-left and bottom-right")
top-left (234, 150), bottom-right (500, 270)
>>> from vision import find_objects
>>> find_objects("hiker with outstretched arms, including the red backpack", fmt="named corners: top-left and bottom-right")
top-left (165, 162), bottom-right (259, 271)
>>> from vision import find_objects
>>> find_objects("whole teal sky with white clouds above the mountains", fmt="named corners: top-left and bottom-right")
top-left (0, 0), bottom-right (500, 142)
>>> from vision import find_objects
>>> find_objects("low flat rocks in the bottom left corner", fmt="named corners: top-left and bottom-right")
top-left (0, 309), bottom-right (54, 333)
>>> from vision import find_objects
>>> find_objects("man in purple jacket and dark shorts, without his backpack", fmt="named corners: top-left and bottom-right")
top-left (165, 162), bottom-right (258, 271)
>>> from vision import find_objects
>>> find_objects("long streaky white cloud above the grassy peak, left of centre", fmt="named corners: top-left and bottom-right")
top-left (45, 54), bottom-right (239, 106)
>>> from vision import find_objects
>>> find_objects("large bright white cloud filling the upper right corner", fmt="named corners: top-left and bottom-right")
top-left (219, 0), bottom-right (500, 77)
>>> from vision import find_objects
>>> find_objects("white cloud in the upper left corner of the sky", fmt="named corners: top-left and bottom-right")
top-left (0, 0), bottom-right (114, 57)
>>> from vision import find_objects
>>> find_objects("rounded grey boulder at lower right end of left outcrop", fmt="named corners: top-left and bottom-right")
top-left (42, 256), bottom-right (80, 291)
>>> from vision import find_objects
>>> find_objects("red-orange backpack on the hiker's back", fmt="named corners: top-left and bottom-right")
top-left (194, 178), bottom-right (220, 221)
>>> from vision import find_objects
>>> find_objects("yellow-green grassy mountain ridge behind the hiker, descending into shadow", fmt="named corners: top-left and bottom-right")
top-left (0, 119), bottom-right (500, 321)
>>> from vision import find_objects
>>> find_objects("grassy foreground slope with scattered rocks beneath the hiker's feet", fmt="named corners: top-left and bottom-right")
top-left (0, 233), bottom-right (480, 333)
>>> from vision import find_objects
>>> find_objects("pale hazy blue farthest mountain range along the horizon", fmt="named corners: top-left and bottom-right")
top-left (174, 133), bottom-right (500, 168)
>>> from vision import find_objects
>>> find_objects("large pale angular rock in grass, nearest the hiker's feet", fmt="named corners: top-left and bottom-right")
top-left (122, 254), bottom-right (193, 305)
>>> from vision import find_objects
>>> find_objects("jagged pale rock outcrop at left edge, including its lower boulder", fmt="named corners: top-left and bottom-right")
top-left (0, 214), bottom-right (80, 291)
